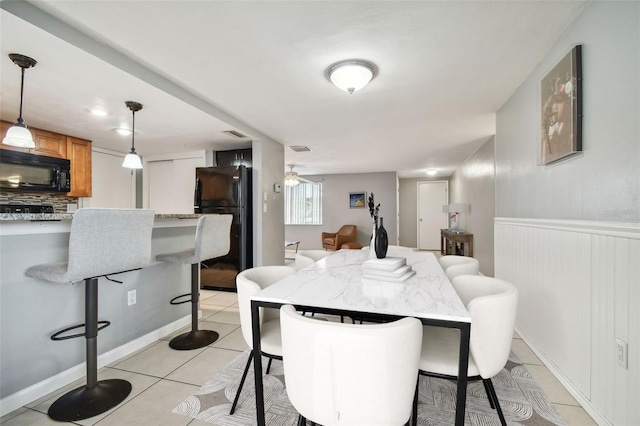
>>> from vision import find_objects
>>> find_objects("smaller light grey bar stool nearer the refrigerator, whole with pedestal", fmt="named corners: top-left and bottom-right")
top-left (156, 214), bottom-right (233, 351)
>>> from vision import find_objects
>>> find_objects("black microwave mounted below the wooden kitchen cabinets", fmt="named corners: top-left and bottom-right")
top-left (0, 149), bottom-right (71, 192)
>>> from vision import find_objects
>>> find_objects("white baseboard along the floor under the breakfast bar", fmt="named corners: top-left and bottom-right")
top-left (0, 313), bottom-right (191, 417)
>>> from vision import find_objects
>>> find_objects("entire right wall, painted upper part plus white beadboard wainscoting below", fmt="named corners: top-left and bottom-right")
top-left (495, 1), bottom-right (640, 425)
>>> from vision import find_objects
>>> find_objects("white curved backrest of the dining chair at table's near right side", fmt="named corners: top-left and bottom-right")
top-left (452, 275), bottom-right (518, 378)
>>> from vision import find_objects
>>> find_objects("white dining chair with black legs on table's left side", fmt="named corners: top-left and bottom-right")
top-left (229, 266), bottom-right (296, 414)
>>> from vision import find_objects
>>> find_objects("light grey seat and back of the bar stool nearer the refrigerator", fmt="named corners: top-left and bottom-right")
top-left (156, 214), bottom-right (233, 265)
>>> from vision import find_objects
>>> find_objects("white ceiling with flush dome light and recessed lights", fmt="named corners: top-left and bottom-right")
top-left (0, 0), bottom-right (585, 178)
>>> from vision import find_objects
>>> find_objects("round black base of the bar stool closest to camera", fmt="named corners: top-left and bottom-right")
top-left (49, 379), bottom-right (131, 422)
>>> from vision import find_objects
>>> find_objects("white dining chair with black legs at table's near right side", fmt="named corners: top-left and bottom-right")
top-left (413, 275), bottom-right (518, 425)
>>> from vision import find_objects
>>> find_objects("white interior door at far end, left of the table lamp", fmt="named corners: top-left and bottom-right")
top-left (418, 181), bottom-right (449, 250)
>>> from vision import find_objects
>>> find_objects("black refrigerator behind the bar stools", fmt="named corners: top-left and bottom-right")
top-left (194, 166), bottom-right (253, 291)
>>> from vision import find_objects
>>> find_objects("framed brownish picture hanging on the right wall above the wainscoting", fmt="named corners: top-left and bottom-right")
top-left (540, 45), bottom-right (582, 165)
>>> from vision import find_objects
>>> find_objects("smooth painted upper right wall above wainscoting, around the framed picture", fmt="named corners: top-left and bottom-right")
top-left (496, 1), bottom-right (640, 222)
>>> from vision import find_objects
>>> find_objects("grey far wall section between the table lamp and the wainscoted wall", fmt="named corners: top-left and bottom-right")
top-left (449, 137), bottom-right (496, 276)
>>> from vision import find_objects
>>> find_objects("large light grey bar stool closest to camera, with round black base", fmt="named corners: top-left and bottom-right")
top-left (26, 208), bottom-right (155, 422)
